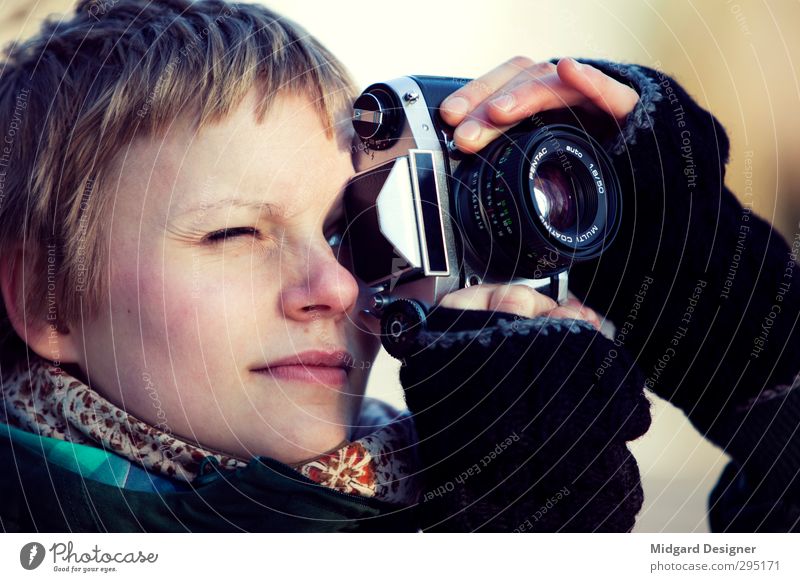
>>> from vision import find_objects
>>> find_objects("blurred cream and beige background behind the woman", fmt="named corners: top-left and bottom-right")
top-left (0, 0), bottom-right (800, 532)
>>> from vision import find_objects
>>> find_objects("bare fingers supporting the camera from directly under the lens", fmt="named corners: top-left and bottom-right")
top-left (439, 284), bottom-right (558, 317)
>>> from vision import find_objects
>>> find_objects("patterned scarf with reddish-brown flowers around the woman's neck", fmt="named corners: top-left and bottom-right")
top-left (0, 358), bottom-right (420, 505)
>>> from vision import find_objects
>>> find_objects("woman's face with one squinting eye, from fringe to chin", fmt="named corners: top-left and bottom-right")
top-left (71, 93), bottom-right (378, 462)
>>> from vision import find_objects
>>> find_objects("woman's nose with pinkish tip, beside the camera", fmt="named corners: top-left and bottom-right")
top-left (281, 243), bottom-right (358, 321)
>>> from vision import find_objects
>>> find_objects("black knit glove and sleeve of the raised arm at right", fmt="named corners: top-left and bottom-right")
top-left (571, 61), bottom-right (800, 527)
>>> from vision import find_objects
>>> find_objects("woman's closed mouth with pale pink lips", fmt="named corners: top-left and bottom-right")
top-left (253, 351), bottom-right (353, 388)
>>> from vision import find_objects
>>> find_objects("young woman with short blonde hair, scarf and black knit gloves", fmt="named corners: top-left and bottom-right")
top-left (0, 0), bottom-right (800, 531)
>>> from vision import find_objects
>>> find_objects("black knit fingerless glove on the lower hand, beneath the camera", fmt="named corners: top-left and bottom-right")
top-left (400, 308), bottom-right (650, 532)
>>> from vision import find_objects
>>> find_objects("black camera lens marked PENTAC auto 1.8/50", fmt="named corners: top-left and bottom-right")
top-left (454, 124), bottom-right (620, 279)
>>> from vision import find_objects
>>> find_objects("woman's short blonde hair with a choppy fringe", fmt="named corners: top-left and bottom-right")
top-left (0, 0), bottom-right (354, 361)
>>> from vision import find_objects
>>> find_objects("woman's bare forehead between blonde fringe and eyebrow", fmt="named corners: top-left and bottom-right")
top-left (112, 91), bottom-right (353, 216)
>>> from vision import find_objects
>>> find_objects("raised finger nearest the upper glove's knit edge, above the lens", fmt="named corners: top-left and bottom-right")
top-left (557, 59), bottom-right (639, 122)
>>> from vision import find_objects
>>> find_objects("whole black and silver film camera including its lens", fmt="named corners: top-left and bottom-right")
top-left (344, 76), bottom-right (621, 357)
